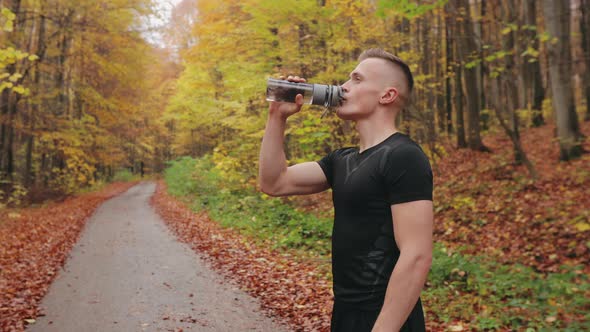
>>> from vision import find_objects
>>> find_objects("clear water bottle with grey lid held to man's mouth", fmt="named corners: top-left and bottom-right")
top-left (266, 78), bottom-right (344, 107)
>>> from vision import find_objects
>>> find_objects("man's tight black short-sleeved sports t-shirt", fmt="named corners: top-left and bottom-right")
top-left (318, 133), bottom-right (432, 310)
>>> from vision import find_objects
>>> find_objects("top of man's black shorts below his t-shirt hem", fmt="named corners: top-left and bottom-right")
top-left (330, 300), bottom-right (426, 332)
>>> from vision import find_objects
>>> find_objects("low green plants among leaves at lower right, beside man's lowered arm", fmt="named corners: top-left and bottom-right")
top-left (424, 246), bottom-right (590, 330)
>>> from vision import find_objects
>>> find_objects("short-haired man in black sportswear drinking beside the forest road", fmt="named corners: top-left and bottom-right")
top-left (259, 49), bottom-right (433, 332)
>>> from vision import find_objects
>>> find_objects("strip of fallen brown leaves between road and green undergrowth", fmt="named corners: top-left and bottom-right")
top-left (151, 181), bottom-right (332, 331)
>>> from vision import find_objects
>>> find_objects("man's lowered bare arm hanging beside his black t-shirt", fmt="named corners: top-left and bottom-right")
top-left (373, 200), bottom-right (434, 332)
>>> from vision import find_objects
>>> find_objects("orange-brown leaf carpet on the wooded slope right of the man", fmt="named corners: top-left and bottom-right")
top-left (435, 123), bottom-right (590, 272)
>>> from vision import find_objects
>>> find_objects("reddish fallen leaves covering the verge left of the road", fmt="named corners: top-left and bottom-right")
top-left (0, 183), bottom-right (138, 331)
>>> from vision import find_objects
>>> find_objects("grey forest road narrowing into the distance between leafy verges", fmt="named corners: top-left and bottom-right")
top-left (27, 182), bottom-right (287, 332)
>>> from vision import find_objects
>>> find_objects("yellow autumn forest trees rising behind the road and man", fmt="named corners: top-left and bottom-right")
top-left (0, 0), bottom-right (590, 200)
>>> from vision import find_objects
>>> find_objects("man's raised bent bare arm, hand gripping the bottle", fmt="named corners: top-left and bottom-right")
top-left (258, 77), bottom-right (329, 196)
